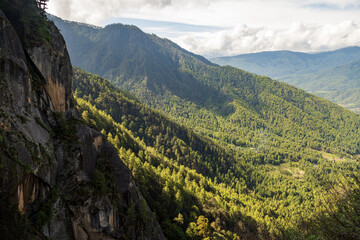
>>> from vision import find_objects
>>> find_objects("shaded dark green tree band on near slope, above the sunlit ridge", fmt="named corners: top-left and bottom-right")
top-left (74, 68), bottom-right (235, 179)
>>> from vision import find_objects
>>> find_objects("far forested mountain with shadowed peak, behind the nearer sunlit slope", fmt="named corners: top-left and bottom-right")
top-left (53, 15), bottom-right (359, 158)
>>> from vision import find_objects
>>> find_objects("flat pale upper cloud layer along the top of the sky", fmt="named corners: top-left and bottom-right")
top-left (49, 0), bottom-right (360, 27)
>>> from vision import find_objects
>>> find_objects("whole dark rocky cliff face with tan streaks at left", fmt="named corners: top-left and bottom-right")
top-left (0, 0), bottom-right (164, 239)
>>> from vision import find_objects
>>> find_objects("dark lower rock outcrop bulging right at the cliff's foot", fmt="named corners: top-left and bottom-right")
top-left (41, 124), bottom-right (164, 239)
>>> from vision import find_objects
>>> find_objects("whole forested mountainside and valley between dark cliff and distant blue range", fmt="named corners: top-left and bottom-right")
top-left (52, 14), bottom-right (360, 239)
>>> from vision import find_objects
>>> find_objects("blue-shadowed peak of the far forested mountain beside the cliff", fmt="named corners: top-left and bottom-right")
top-left (50, 13), bottom-right (222, 109)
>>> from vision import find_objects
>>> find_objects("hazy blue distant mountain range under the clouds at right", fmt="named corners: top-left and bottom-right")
top-left (212, 47), bottom-right (360, 112)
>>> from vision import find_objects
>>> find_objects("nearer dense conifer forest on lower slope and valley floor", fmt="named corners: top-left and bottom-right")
top-left (74, 68), bottom-right (358, 239)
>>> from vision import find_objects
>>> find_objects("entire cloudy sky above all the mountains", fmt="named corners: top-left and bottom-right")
top-left (48, 0), bottom-right (360, 58)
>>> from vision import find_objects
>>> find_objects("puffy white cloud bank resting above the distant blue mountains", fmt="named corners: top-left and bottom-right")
top-left (172, 21), bottom-right (360, 57)
